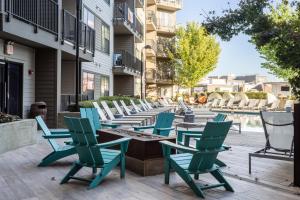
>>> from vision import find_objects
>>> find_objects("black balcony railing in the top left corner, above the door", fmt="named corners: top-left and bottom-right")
top-left (5, 0), bottom-right (58, 35)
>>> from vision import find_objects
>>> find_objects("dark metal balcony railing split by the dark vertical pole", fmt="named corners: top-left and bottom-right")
top-left (62, 10), bottom-right (95, 53)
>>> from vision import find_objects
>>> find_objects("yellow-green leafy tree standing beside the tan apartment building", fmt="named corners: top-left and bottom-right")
top-left (169, 22), bottom-right (221, 93)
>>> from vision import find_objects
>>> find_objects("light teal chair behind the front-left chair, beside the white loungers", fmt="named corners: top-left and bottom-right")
top-left (80, 108), bottom-right (120, 130)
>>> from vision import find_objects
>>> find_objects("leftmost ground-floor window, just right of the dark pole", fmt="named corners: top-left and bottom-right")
top-left (82, 72), bottom-right (95, 99)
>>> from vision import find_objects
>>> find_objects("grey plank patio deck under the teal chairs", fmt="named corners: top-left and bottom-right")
top-left (0, 130), bottom-right (300, 200)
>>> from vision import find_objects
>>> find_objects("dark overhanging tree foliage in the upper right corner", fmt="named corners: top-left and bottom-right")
top-left (203, 0), bottom-right (300, 99)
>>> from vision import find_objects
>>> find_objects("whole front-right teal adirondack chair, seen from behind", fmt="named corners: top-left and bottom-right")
top-left (160, 121), bottom-right (234, 198)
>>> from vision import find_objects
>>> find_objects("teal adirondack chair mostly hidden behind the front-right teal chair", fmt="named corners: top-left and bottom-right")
top-left (177, 113), bottom-right (227, 146)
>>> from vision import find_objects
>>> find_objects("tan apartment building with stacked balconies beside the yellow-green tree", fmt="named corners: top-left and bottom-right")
top-left (145, 0), bottom-right (182, 98)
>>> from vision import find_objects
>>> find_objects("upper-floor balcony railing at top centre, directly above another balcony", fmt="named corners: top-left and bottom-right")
top-left (114, 2), bottom-right (144, 38)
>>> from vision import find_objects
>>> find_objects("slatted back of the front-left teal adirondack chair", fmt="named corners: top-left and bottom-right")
top-left (65, 117), bottom-right (104, 167)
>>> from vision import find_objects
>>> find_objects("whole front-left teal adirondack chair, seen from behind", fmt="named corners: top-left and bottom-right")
top-left (61, 117), bottom-right (130, 189)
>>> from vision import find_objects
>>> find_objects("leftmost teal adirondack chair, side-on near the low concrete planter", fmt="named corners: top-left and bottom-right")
top-left (35, 116), bottom-right (76, 167)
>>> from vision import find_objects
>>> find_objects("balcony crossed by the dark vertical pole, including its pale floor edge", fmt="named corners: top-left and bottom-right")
top-left (61, 10), bottom-right (95, 60)
